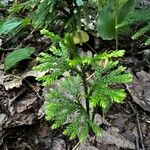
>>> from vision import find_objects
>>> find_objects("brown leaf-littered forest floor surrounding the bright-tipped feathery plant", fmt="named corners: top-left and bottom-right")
top-left (0, 31), bottom-right (150, 150)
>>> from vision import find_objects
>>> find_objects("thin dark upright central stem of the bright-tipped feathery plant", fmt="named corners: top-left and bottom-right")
top-left (81, 66), bottom-right (90, 115)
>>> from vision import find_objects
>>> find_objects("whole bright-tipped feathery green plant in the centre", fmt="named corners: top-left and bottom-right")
top-left (35, 30), bottom-right (132, 142)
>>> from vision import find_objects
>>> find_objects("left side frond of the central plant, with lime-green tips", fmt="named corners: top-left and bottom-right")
top-left (34, 53), bottom-right (69, 86)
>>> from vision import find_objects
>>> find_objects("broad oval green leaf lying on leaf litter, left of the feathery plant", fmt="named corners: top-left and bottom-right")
top-left (4, 47), bottom-right (35, 70)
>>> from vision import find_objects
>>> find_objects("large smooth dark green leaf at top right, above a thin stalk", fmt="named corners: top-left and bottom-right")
top-left (97, 0), bottom-right (135, 40)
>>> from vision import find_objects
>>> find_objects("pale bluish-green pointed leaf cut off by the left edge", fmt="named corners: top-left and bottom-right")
top-left (0, 18), bottom-right (23, 35)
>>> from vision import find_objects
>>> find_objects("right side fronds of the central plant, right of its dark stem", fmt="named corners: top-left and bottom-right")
top-left (90, 51), bottom-right (132, 110)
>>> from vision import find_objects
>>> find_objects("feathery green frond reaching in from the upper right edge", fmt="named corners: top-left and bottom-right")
top-left (117, 8), bottom-right (150, 45)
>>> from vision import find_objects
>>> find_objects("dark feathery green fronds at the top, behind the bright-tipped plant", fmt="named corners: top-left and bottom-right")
top-left (9, 0), bottom-right (92, 30)
